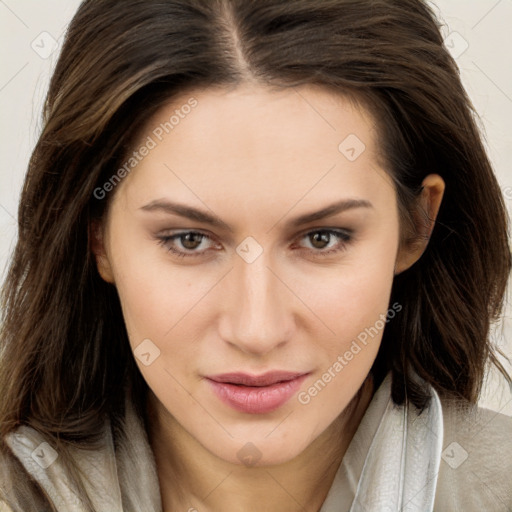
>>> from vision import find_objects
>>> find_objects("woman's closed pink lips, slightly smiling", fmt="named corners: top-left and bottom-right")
top-left (207, 371), bottom-right (308, 414)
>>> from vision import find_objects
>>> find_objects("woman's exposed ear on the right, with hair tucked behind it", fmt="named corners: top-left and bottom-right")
top-left (395, 174), bottom-right (445, 275)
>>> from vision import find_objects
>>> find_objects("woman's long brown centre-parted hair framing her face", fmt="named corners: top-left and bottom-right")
top-left (0, 0), bottom-right (511, 503)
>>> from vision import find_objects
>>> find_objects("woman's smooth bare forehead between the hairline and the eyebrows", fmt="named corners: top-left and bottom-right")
top-left (113, 85), bottom-right (389, 214)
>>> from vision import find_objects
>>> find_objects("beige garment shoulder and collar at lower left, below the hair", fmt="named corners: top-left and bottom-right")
top-left (0, 424), bottom-right (121, 512)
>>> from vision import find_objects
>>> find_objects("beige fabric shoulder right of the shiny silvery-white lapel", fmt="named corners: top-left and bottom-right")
top-left (435, 399), bottom-right (512, 512)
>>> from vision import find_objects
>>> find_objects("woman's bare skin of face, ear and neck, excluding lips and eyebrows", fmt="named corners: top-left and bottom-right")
top-left (93, 85), bottom-right (444, 512)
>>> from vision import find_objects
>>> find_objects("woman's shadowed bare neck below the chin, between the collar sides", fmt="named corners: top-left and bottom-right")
top-left (148, 378), bottom-right (374, 512)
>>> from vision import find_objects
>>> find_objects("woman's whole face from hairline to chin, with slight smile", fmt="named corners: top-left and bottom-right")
top-left (98, 86), bottom-right (414, 464)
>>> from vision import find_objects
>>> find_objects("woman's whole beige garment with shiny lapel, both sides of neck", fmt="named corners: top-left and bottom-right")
top-left (0, 374), bottom-right (512, 512)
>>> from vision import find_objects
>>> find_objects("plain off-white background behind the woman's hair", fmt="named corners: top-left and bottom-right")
top-left (0, 0), bottom-right (512, 416)
